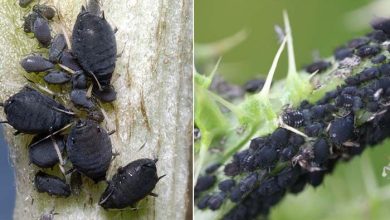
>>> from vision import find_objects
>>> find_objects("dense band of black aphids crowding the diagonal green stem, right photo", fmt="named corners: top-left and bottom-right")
top-left (195, 19), bottom-right (390, 219)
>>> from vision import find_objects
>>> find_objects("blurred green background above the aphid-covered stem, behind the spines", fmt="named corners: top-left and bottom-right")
top-left (195, 0), bottom-right (371, 83)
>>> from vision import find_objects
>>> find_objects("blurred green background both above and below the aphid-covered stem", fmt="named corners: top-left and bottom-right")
top-left (195, 0), bottom-right (390, 220)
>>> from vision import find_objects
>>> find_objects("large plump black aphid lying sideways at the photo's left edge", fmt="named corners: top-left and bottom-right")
top-left (4, 87), bottom-right (73, 134)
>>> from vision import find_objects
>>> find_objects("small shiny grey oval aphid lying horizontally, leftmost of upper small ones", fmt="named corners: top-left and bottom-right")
top-left (20, 54), bottom-right (54, 73)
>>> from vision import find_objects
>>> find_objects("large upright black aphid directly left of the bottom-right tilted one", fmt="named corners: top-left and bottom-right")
top-left (66, 120), bottom-right (112, 182)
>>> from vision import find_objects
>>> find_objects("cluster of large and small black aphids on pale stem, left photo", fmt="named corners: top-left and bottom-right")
top-left (2, 1), bottom-right (162, 209)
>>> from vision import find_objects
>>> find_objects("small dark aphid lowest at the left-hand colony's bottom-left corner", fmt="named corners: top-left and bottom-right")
top-left (34, 171), bottom-right (71, 197)
